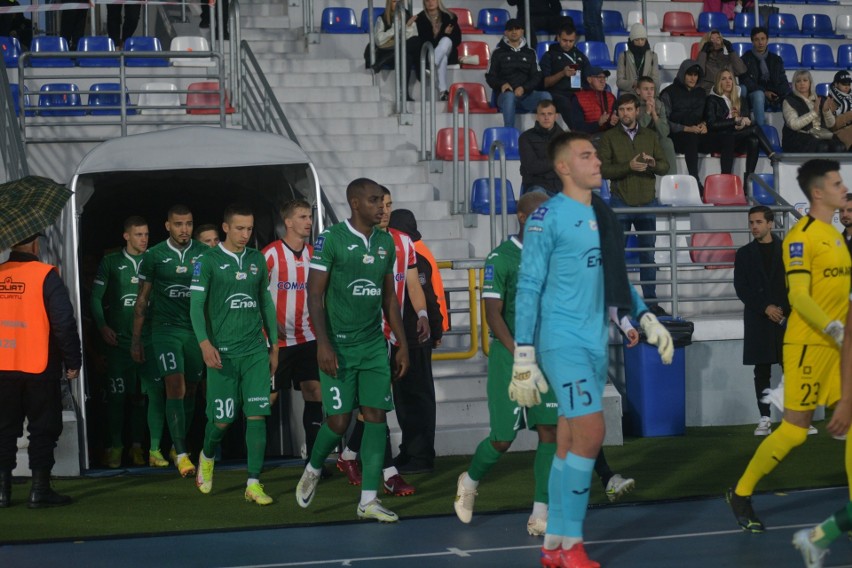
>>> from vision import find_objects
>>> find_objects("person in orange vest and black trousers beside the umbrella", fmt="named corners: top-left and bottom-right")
top-left (0, 234), bottom-right (82, 509)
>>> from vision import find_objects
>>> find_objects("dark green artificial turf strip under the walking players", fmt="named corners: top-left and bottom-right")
top-left (0, 423), bottom-right (846, 543)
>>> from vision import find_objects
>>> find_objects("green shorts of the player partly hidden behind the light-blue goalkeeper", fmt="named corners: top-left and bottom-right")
top-left (486, 340), bottom-right (557, 442)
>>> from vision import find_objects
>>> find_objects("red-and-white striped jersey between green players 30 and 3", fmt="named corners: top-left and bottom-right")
top-left (263, 240), bottom-right (316, 347)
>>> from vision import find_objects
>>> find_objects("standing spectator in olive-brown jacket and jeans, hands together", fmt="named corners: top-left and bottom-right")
top-left (598, 93), bottom-right (669, 315)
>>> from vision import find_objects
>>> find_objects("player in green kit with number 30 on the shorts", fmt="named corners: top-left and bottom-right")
top-left (190, 205), bottom-right (278, 505)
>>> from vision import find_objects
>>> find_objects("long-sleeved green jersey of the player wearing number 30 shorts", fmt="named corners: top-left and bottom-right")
top-left (190, 243), bottom-right (278, 357)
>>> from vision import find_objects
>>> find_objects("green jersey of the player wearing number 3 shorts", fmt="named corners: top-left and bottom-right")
top-left (311, 221), bottom-right (396, 345)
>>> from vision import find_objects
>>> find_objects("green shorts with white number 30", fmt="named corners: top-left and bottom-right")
top-left (207, 352), bottom-right (270, 424)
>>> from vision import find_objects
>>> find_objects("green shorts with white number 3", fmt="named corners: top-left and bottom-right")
top-left (320, 335), bottom-right (393, 416)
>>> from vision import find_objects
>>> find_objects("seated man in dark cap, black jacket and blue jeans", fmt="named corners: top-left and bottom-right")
top-left (485, 18), bottom-right (551, 127)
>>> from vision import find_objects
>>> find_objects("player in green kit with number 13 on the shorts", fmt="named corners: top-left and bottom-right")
top-left (131, 205), bottom-right (209, 477)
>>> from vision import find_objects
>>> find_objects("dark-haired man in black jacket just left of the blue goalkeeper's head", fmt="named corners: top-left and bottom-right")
top-left (518, 101), bottom-right (563, 197)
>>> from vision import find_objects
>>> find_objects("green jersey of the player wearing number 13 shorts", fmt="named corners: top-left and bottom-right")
top-left (139, 239), bottom-right (209, 331)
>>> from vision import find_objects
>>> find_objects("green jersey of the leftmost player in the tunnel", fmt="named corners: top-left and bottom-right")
top-left (92, 249), bottom-right (142, 348)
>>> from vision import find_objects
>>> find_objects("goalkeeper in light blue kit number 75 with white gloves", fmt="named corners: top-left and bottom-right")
top-left (509, 132), bottom-right (674, 568)
